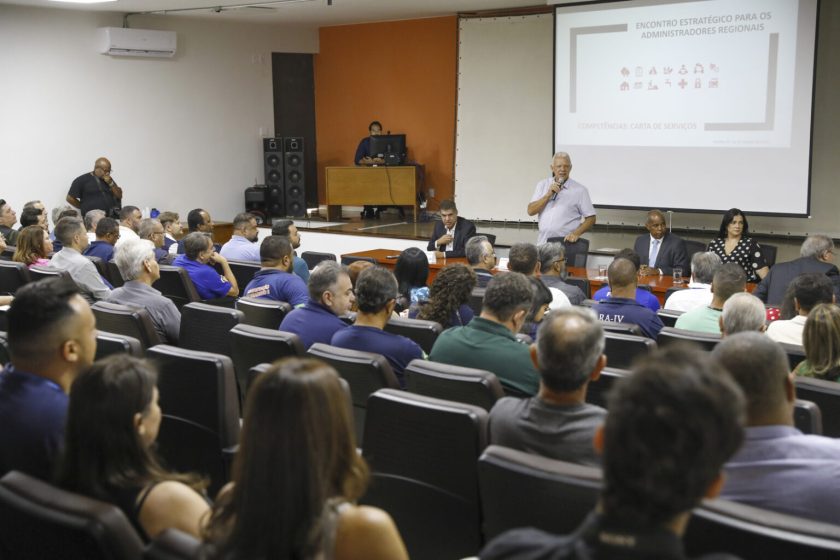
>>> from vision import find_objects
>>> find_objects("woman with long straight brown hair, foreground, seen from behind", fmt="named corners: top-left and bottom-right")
top-left (204, 358), bottom-right (408, 560)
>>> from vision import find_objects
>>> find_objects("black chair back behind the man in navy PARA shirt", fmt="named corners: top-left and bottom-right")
top-left (229, 323), bottom-right (304, 409)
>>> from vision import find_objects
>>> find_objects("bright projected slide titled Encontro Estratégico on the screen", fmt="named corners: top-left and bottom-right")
top-left (554, 0), bottom-right (816, 214)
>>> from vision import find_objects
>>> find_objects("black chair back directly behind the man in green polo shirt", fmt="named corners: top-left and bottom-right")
top-left (405, 360), bottom-right (505, 411)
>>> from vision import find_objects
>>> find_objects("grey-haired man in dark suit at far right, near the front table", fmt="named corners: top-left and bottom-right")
top-left (753, 235), bottom-right (840, 305)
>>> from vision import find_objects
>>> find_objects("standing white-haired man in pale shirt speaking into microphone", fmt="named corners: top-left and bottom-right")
top-left (528, 152), bottom-right (595, 245)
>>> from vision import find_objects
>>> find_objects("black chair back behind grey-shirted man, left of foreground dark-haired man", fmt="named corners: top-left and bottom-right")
top-left (478, 445), bottom-right (601, 540)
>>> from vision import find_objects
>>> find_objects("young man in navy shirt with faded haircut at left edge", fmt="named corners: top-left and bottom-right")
top-left (0, 278), bottom-right (96, 480)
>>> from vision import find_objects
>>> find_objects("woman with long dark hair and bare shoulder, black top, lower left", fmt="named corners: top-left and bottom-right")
top-left (56, 354), bottom-right (210, 541)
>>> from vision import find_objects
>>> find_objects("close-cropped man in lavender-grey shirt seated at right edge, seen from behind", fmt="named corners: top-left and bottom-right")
top-left (713, 333), bottom-right (840, 525)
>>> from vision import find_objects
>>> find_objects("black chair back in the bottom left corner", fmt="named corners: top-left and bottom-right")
top-left (0, 471), bottom-right (143, 560)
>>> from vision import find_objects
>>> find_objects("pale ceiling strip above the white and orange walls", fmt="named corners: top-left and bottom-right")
top-left (0, 0), bottom-right (546, 27)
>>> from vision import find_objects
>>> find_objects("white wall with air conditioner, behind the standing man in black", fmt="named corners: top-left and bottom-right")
top-left (0, 5), bottom-right (318, 220)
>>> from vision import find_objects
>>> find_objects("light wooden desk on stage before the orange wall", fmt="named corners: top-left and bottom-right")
top-left (326, 165), bottom-right (420, 222)
